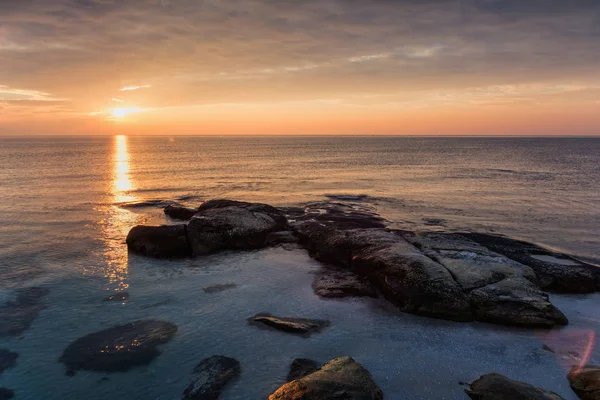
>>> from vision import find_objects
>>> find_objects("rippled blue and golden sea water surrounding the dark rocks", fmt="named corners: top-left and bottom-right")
top-left (0, 136), bottom-right (600, 400)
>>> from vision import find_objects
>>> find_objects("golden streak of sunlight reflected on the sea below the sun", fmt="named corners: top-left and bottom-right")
top-left (100, 136), bottom-right (138, 291)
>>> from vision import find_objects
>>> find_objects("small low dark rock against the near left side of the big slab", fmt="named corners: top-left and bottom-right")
top-left (312, 268), bottom-right (377, 298)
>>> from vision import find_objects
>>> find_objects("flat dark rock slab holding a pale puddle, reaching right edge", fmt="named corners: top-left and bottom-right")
top-left (461, 233), bottom-right (600, 293)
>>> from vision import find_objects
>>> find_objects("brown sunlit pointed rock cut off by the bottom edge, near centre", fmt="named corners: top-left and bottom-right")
top-left (269, 357), bottom-right (383, 400)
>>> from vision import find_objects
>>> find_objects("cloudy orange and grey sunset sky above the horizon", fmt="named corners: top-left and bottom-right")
top-left (0, 0), bottom-right (600, 135)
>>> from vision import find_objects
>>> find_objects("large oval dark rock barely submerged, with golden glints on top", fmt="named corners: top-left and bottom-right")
top-left (59, 320), bottom-right (177, 375)
